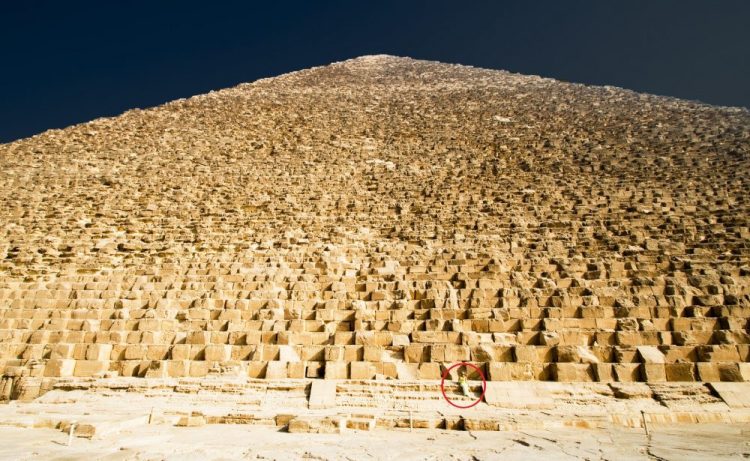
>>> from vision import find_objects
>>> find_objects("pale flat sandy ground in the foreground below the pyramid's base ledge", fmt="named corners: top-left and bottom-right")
top-left (0, 425), bottom-right (750, 461)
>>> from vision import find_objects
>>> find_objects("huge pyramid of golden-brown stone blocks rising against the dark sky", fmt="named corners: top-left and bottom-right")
top-left (0, 55), bottom-right (750, 442)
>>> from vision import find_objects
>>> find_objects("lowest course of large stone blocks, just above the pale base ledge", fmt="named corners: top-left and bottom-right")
top-left (16, 359), bottom-right (750, 383)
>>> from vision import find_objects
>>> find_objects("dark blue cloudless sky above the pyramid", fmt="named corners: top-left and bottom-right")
top-left (0, 0), bottom-right (750, 142)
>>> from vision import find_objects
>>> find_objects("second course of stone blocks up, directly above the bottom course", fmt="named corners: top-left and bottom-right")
top-left (0, 343), bottom-right (750, 363)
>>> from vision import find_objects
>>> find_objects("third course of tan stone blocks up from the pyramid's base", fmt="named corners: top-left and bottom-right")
top-left (0, 330), bottom-right (750, 354)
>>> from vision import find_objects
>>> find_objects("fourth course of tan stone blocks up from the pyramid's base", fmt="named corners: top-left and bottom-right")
top-left (0, 307), bottom-right (750, 333)
